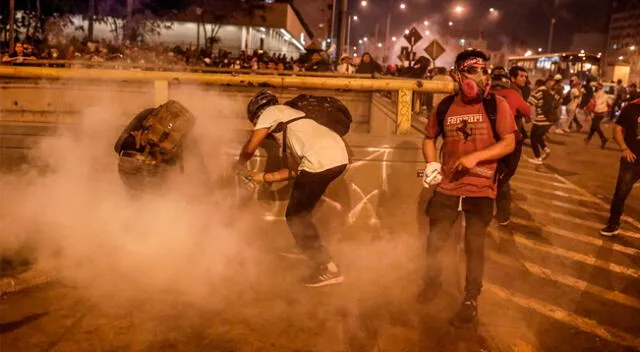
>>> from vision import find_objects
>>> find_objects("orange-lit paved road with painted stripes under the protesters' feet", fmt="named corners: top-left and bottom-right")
top-left (0, 130), bottom-right (640, 352)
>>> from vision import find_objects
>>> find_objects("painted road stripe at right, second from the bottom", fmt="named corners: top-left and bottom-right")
top-left (487, 251), bottom-right (640, 309)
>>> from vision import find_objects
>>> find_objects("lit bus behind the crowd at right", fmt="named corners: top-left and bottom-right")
top-left (508, 51), bottom-right (602, 82)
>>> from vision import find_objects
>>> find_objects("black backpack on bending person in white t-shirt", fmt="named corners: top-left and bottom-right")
top-left (284, 94), bottom-right (353, 137)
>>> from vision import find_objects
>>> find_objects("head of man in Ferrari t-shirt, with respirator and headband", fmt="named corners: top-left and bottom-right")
top-left (453, 49), bottom-right (490, 102)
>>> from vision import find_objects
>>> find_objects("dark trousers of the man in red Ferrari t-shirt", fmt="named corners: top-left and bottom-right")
top-left (425, 192), bottom-right (493, 299)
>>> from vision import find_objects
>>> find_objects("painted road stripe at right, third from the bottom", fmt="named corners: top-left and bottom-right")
top-left (489, 229), bottom-right (640, 278)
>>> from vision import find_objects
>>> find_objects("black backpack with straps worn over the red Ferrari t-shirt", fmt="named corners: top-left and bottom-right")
top-left (436, 93), bottom-right (519, 181)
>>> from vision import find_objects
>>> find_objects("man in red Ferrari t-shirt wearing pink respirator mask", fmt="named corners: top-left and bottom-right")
top-left (418, 49), bottom-right (517, 326)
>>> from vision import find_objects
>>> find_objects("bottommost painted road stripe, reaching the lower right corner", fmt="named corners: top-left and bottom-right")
top-left (484, 281), bottom-right (640, 348)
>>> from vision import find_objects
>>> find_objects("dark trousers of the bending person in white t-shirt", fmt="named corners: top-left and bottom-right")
top-left (285, 165), bottom-right (347, 265)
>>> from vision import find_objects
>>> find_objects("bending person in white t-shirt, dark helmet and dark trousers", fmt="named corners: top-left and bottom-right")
top-left (237, 90), bottom-right (349, 287)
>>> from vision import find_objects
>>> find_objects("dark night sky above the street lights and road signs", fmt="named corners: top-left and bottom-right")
top-left (349, 0), bottom-right (611, 51)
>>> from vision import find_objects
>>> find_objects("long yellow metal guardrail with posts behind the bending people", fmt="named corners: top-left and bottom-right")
top-left (0, 65), bottom-right (453, 134)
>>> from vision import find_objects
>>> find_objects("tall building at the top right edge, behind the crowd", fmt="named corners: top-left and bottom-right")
top-left (604, 0), bottom-right (640, 84)
